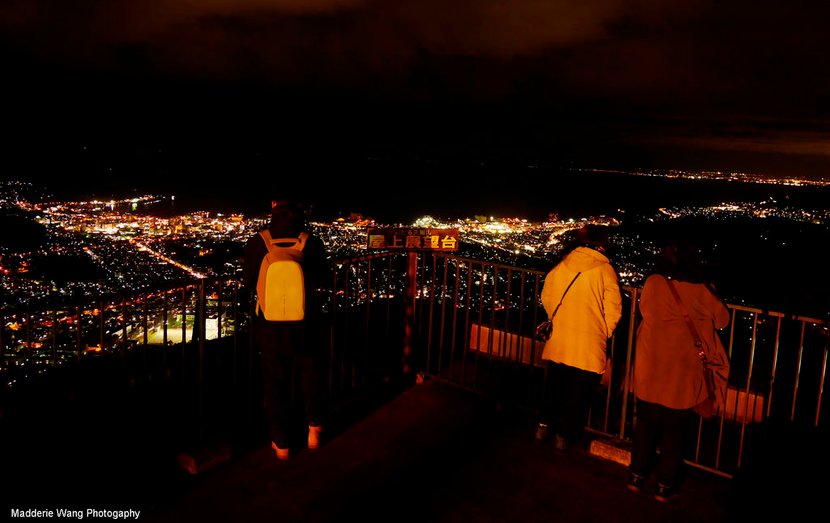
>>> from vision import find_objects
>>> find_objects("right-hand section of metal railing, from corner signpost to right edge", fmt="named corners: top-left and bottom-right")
top-left (417, 254), bottom-right (830, 477)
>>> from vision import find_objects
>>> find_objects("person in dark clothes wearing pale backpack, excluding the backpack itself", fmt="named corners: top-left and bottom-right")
top-left (243, 199), bottom-right (332, 460)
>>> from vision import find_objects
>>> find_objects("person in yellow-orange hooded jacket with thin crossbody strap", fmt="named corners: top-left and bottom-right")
top-left (536, 224), bottom-right (622, 450)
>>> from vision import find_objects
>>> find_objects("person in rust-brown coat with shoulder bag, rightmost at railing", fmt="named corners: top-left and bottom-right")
top-left (628, 233), bottom-right (729, 502)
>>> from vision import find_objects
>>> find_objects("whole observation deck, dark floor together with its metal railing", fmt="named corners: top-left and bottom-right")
top-left (0, 253), bottom-right (830, 522)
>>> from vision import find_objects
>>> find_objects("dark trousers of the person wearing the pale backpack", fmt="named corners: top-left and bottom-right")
top-left (255, 324), bottom-right (325, 448)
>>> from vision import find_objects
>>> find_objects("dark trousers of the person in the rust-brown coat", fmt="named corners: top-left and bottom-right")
top-left (629, 400), bottom-right (695, 487)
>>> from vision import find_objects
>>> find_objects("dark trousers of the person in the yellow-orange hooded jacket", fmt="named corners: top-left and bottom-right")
top-left (541, 361), bottom-right (602, 442)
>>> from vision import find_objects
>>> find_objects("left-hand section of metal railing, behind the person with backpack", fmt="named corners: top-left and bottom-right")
top-left (0, 254), bottom-right (406, 447)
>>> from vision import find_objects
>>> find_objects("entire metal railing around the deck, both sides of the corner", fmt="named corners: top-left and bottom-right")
top-left (0, 253), bottom-right (830, 477)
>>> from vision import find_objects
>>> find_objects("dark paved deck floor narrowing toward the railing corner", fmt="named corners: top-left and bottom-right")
top-left (141, 382), bottom-right (743, 523)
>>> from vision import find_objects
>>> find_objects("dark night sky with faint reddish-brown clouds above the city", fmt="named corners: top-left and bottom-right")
top-left (0, 0), bottom-right (830, 188)
